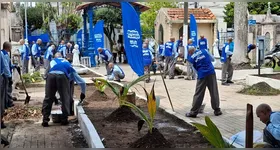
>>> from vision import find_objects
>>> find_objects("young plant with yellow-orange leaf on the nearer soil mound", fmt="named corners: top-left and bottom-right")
top-left (123, 82), bottom-right (160, 133)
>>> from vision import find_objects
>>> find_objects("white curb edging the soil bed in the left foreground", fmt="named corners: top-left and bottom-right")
top-left (74, 101), bottom-right (105, 148)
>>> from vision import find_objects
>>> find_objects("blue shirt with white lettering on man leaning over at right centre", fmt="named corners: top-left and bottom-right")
top-left (188, 49), bottom-right (215, 79)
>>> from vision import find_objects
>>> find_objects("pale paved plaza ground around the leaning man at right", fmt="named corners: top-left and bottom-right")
top-left (92, 65), bottom-right (280, 138)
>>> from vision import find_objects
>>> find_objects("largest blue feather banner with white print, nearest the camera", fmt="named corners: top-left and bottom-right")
top-left (121, 2), bottom-right (144, 76)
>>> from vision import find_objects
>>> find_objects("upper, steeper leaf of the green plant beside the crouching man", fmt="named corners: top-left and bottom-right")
top-left (205, 116), bottom-right (225, 148)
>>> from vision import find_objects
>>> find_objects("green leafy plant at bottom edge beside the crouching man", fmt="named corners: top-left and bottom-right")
top-left (192, 116), bottom-right (235, 148)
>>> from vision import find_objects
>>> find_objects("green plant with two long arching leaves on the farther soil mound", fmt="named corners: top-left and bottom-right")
top-left (95, 75), bottom-right (148, 106)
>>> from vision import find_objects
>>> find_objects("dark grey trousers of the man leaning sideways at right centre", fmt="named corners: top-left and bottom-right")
top-left (191, 74), bottom-right (220, 114)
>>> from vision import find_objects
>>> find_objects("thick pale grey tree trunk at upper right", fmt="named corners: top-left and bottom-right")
top-left (232, 2), bottom-right (249, 65)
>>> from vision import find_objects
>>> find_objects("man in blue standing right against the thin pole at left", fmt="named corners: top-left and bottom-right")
top-left (19, 39), bottom-right (30, 74)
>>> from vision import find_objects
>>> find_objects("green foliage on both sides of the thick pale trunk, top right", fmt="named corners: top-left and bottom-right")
top-left (224, 2), bottom-right (280, 27)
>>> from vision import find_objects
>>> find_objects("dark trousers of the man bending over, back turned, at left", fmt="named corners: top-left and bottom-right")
top-left (42, 73), bottom-right (70, 122)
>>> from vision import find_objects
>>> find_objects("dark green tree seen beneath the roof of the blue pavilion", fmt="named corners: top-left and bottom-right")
top-left (93, 6), bottom-right (122, 49)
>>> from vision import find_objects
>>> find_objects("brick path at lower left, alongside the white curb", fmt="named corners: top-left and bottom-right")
top-left (1, 87), bottom-right (76, 148)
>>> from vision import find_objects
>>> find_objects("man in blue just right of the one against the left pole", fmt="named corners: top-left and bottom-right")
top-left (31, 39), bottom-right (42, 71)
